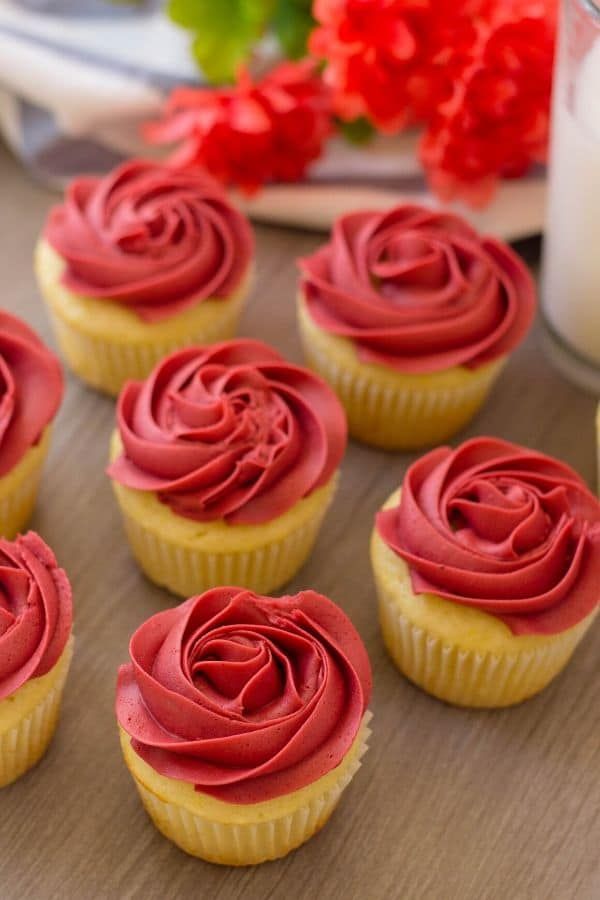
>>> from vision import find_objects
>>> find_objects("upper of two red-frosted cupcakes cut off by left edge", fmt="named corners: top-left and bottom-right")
top-left (0, 310), bottom-right (63, 538)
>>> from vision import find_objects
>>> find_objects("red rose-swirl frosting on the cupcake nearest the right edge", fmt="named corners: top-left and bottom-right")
top-left (376, 438), bottom-right (600, 634)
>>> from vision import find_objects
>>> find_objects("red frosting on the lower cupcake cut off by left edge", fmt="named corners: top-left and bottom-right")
top-left (0, 531), bottom-right (73, 700)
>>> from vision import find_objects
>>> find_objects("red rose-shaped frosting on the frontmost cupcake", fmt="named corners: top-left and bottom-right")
top-left (116, 587), bottom-right (371, 803)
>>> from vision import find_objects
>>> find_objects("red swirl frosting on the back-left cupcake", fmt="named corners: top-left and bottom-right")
top-left (44, 159), bottom-right (253, 322)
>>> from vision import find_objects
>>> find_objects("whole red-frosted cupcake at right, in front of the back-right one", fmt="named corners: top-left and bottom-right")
top-left (371, 438), bottom-right (600, 707)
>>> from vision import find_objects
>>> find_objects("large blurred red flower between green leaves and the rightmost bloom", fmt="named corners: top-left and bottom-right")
top-left (309, 0), bottom-right (485, 132)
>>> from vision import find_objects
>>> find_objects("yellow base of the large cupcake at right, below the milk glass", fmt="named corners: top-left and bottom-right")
top-left (371, 493), bottom-right (597, 708)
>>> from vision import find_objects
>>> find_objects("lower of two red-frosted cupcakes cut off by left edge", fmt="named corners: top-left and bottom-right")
top-left (0, 531), bottom-right (73, 787)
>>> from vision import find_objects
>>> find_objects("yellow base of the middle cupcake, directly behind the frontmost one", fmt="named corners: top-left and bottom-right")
top-left (111, 434), bottom-right (337, 597)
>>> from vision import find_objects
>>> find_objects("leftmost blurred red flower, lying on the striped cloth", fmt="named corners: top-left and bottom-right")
top-left (144, 61), bottom-right (331, 192)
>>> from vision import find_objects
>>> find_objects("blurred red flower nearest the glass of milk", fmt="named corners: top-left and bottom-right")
top-left (421, 8), bottom-right (554, 205)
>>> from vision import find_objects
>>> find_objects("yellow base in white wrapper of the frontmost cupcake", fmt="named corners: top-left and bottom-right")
top-left (120, 712), bottom-right (371, 866)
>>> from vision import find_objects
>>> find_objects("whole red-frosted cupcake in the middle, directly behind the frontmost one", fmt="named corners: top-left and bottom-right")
top-left (108, 339), bottom-right (346, 597)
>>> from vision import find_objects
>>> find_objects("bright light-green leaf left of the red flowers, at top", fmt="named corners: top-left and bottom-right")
top-left (168, 0), bottom-right (274, 82)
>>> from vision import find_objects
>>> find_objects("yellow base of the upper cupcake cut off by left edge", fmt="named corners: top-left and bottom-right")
top-left (0, 426), bottom-right (52, 540)
